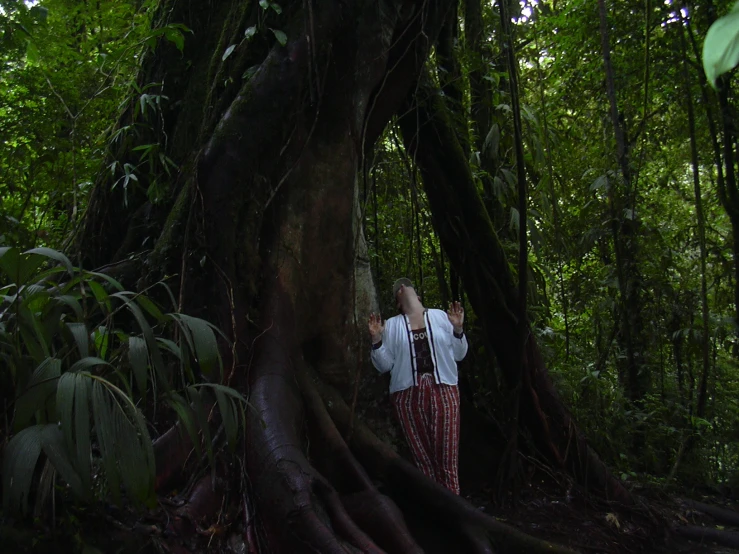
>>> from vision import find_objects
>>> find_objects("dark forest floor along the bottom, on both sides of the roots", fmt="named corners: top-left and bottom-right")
top-left (0, 478), bottom-right (739, 554)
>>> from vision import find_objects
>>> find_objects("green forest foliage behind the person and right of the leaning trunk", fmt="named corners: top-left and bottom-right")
top-left (363, 0), bottom-right (739, 485)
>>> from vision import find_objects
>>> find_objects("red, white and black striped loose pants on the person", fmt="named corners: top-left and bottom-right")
top-left (392, 373), bottom-right (459, 494)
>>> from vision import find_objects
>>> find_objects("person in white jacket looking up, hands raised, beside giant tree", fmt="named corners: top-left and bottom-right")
top-left (368, 278), bottom-right (467, 494)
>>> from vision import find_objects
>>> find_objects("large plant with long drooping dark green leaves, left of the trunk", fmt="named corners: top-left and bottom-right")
top-left (0, 247), bottom-right (245, 511)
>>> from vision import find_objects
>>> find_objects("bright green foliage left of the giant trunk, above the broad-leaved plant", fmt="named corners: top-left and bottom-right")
top-left (0, 0), bottom-right (187, 248)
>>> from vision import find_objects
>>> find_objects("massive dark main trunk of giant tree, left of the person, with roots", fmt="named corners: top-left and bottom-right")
top-left (79, 0), bottom-right (615, 553)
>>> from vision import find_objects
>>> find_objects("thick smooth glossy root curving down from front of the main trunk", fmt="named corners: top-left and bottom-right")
top-left (247, 290), bottom-right (390, 554)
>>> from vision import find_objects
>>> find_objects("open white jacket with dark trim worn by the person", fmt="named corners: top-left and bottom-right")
top-left (370, 310), bottom-right (467, 394)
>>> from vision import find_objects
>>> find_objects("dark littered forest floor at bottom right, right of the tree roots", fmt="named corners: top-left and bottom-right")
top-left (465, 470), bottom-right (739, 554)
